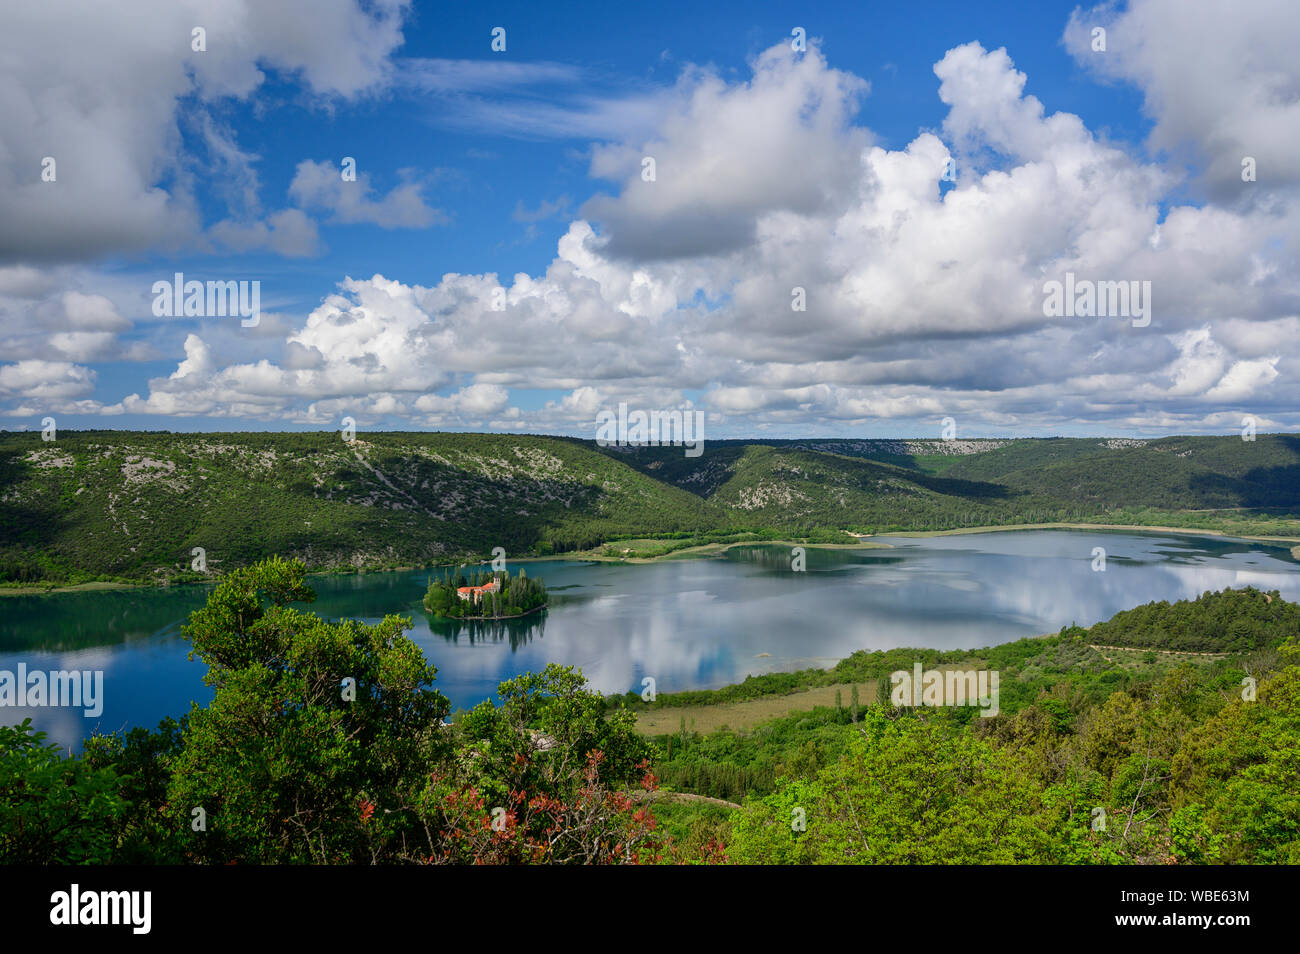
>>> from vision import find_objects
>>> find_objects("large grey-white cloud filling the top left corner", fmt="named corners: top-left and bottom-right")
top-left (0, 0), bottom-right (408, 265)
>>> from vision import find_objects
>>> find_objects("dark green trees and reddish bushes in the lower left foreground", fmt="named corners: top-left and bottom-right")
top-left (0, 559), bottom-right (702, 864)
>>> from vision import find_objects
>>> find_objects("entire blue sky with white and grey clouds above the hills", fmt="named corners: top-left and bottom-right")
top-left (0, 0), bottom-right (1300, 438)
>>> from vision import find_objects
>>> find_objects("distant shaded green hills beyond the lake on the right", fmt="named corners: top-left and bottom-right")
top-left (618, 435), bottom-right (1300, 519)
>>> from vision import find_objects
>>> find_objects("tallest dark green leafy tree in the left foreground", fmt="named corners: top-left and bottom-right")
top-left (168, 559), bottom-right (449, 863)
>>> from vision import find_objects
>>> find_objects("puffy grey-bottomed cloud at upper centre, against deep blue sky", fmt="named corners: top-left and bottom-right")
top-left (582, 43), bottom-right (867, 260)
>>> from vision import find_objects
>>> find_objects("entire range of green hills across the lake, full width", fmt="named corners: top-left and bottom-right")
top-left (0, 432), bottom-right (1300, 582)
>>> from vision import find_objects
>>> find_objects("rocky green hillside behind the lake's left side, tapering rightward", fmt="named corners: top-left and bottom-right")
top-left (0, 432), bottom-right (725, 580)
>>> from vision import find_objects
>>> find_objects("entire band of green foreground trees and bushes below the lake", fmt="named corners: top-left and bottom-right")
top-left (0, 560), bottom-right (1300, 864)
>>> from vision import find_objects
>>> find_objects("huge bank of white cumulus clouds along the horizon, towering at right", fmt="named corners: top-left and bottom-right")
top-left (10, 0), bottom-right (1300, 435)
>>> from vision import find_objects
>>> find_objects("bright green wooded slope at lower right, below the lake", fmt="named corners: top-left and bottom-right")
top-left (642, 589), bottom-right (1300, 864)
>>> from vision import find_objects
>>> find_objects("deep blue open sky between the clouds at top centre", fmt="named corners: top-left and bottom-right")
top-left (185, 3), bottom-right (1149, 289)
